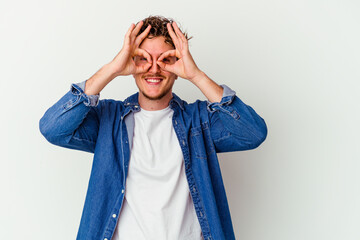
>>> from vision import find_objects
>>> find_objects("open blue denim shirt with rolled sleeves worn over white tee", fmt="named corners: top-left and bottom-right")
top-left (40, 82), bottom-right (267, 240)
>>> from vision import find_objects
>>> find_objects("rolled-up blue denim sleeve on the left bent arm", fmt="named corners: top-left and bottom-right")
top-left (39, 82), bottom-right (101, 152)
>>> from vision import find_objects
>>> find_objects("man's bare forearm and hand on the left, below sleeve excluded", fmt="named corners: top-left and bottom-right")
top-left (85, 21), bottom-right (152, 95)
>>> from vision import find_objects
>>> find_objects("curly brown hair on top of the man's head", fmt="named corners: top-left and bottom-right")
top-left (138, 16), bottom-right (192, 48)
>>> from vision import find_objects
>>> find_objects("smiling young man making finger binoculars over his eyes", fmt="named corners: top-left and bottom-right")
top-left (40, 17), bottom-right (267, 240)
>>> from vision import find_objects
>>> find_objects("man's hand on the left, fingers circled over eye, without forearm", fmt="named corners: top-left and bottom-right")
top-left (109, 21), bottom-right (152, 76)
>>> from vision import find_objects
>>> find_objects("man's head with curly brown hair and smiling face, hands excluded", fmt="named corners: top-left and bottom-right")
top-left (133, 16), bottom-right (191, 106)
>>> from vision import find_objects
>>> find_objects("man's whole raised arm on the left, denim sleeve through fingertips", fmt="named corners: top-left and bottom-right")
top-left (39, 22), bottom-right (151, 152)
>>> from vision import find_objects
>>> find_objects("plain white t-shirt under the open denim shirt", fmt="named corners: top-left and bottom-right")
top-left (112, 107), bottom-right (203, 240)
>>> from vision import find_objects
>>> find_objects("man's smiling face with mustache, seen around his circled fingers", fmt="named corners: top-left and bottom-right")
top-left (133, 37), bottom-right (177, 101)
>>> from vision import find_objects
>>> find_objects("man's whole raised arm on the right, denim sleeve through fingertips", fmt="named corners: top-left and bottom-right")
top-left (158, 22), bottom-right (267, 152)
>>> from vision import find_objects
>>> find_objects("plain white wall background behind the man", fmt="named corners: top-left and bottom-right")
top-left (0, 0), bottom-right (360, 240)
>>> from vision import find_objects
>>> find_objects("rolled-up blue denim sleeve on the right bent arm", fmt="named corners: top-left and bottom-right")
top-left (207, 85), bottom-right (267, 152)
